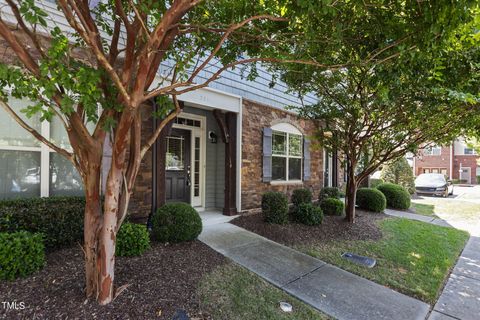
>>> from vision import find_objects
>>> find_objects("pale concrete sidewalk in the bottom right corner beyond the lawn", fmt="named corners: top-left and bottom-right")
top-left (428, 236), bottom-right (480, 320)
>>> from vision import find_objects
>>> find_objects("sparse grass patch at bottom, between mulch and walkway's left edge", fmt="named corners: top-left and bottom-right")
top-left (198, 264), bottom-right (330, 320)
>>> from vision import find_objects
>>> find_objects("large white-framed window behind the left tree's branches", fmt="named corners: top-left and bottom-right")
top-left (0, 97), bottom-right (85, 199)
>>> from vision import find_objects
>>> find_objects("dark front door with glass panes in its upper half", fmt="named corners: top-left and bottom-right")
top-left (165, 129), bottom-right (191, 203)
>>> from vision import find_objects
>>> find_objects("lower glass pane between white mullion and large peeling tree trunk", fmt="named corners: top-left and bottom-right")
top-left (50, 152), bottom-right (84, 196)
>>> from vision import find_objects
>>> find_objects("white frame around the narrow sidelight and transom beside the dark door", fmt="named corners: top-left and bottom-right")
top-left (171, 112), bottom-right (207, 211)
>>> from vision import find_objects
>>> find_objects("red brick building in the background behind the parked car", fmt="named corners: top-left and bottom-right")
top-left (413, 138), bottom-right (480, 184)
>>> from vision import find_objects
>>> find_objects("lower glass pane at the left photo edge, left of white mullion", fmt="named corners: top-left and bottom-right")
top-left (0, 150), bottom-right (40, 199)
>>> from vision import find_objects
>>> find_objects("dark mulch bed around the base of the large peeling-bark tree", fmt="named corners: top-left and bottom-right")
top-left (0, 241), bottom-right (226, 319)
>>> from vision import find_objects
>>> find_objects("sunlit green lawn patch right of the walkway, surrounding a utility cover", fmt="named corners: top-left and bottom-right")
top-left (297, 218), bottom-right (468, 303)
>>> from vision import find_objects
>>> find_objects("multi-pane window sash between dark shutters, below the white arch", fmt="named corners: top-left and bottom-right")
top-left (272, 131), bottom-right (303, 181)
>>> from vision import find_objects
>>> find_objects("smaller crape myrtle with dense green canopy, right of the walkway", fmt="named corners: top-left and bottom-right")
top-left (278, 0), bottom-right (478, 223)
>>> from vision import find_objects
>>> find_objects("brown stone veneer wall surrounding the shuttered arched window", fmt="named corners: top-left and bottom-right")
top-left (242, 99), bottom-right (323, 211)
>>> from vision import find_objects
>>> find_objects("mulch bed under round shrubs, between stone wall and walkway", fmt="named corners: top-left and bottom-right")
top-left (231, 209), bottom-right (386, 246)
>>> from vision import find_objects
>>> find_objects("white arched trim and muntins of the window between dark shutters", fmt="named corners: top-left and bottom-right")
top-left (270, 128), bottom-right (303, 184)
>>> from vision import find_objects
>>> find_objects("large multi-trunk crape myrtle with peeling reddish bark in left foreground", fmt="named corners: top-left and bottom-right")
top-left (0, 0), bottom-right (334, 304)
